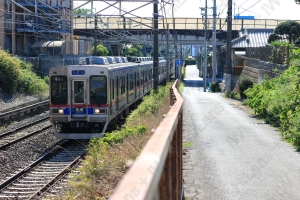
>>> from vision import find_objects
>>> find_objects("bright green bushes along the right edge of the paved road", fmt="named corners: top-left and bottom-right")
top-left (245, 61), bottom-right (300, 149)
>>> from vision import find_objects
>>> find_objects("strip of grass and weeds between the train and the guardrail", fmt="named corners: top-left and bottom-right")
top-left (61, 84), bottom-right (171, 199)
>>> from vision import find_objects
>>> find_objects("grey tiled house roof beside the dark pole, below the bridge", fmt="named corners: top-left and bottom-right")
top-left (232, 28), bottom-right (274, 48)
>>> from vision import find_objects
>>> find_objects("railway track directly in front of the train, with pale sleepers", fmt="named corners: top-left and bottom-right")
top-left (0, 140), bottom-right (86, 199)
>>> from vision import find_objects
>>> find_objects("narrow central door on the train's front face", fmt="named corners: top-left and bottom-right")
top-left (71, 79), bottom-right (88, 119)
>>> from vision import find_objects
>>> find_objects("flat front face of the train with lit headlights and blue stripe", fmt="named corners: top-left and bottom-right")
top-left (49, 65), bottom-right (108, 139)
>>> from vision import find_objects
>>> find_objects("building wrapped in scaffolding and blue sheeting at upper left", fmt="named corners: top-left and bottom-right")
top-left (0, 0), bottom-right (73, 57)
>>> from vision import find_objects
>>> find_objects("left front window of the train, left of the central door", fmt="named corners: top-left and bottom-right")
top-left (51, 76), bottom-right (68, 104)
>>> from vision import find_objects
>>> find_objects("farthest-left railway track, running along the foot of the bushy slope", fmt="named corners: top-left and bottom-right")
top-left (0, 100), bottom-right (49, 122)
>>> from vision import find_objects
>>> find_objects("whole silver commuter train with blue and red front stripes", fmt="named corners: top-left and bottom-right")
top-left (49, 56), bottom-right (174, 139)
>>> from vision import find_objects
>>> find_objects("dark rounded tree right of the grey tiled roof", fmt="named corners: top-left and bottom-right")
top-left (268, 20), bottom-right (300, 65)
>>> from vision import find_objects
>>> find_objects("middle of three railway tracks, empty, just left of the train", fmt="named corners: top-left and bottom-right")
top-left (0, 116), bottom-right (51, 150)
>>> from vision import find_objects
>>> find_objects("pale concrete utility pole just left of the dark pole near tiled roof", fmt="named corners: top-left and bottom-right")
top-left (212, 0), bottom-right (217, 82)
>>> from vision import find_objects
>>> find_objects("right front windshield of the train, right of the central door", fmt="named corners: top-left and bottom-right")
top-left (90, 76), bottom-right (107, 106)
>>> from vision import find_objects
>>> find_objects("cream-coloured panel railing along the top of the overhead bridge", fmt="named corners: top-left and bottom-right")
top-left (73, 17), bottom-right (300, 31)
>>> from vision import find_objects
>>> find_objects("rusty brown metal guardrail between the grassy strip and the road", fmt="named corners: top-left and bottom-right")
top-left (110, 80), bottom-right (183, 200)
